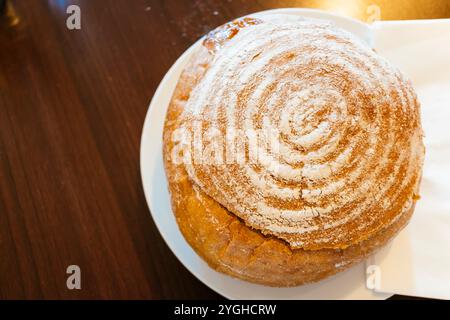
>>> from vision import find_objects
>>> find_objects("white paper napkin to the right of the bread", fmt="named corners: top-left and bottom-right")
top-left (368, 19), bottom-right (450, 299)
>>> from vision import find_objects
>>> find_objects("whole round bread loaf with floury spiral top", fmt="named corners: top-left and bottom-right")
top-left (164, 15), bottom-right (424, 286)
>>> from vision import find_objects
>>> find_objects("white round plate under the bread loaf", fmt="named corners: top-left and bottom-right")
top-left (141, 9), bottom-right (390, 299)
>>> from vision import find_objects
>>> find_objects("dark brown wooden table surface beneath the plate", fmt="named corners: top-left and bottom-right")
top-left (0, 0), bottom-right (450, 299)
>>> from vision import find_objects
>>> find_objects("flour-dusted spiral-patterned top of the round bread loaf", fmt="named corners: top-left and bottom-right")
top-left (174, 15), bottom-right (424, 249)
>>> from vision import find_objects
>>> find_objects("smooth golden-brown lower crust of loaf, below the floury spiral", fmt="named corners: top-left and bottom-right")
top-left (163, 15), bottom-right (422, 286)
